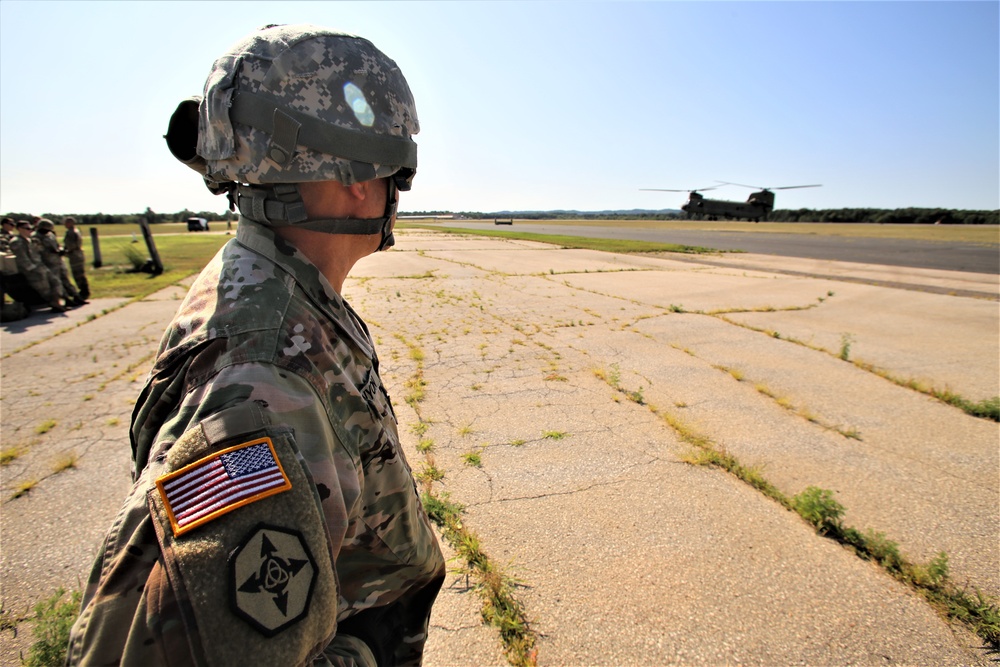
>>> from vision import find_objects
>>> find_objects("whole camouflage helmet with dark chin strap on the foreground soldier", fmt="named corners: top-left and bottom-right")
top-left (166, 24), bottom-right (420, 250)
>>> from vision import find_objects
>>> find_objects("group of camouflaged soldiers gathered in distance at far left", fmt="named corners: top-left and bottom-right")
top-left (0, 216), bottom-right (90, 320)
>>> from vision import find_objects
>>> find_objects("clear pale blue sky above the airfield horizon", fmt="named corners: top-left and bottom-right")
top-left (0, 0), bottom-right (1000, 213)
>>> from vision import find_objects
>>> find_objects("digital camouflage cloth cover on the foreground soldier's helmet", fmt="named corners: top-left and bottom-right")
top-left (197, 24), bottom-right (420, 185)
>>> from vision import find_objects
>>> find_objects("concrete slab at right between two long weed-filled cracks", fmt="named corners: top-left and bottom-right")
top-left (596, 314), bottom-right (1000, 595)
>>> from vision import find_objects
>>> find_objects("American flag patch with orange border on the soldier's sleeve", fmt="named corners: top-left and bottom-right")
top-left (156, 438), bottom-right (292, 535)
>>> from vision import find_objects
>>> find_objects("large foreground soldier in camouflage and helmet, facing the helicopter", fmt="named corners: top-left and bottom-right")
top-left (68, 25), bottom-right (444, 665)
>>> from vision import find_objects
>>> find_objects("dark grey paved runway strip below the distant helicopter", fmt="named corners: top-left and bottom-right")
top-left (442, 220), bottom-right (1000, 275)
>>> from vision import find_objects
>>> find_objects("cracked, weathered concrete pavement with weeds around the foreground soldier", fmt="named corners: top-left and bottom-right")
top-left (0, 230), bottom-right (1000, 667)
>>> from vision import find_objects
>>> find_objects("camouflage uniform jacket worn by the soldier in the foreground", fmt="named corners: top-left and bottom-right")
top-left (69, 218), bottom-right (444, 665)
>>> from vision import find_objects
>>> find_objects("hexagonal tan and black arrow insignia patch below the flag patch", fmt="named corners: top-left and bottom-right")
top-left (229, 523), bottom-right (316, 637)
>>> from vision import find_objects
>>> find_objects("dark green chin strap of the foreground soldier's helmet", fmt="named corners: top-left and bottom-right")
top-left (230, 178), bottom-right (398, 252)
